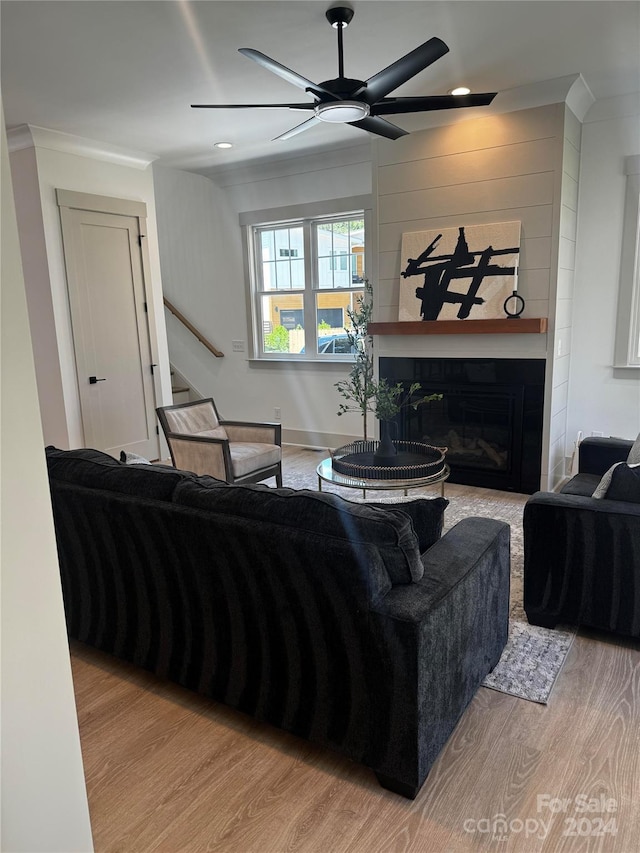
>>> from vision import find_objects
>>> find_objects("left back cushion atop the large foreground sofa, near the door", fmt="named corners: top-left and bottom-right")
top-left (46, 447), bottom-right (189, 501)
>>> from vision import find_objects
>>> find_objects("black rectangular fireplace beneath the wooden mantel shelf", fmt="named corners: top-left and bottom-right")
top-left (379, 358), bottom-right (545, 494)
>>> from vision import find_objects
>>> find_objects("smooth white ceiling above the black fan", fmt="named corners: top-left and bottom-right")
top-left (0, 0), bottom-right (640, 174)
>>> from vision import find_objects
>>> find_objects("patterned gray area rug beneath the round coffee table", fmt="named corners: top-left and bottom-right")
top-left (283, 449), bottom-right (575, 705)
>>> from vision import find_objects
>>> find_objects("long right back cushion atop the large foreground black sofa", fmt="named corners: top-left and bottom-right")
top-left (173, 480), bottom-right (424, 584)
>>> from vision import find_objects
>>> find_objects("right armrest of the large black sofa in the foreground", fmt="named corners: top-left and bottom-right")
top-left (371, 518), bottom-right (510, 797)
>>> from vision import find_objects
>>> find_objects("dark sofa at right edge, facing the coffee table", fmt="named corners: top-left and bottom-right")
top-left (523, 437), bottom-right (640, 638)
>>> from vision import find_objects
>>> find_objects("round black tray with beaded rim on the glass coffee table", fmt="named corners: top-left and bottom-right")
top-left (331, 441), bottom-right (447, 480)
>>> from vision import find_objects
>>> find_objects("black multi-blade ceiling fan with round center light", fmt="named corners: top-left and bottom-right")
top-left (191, 6), bottom-right (497, 139)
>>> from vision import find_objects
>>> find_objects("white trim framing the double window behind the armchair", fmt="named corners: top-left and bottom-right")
top-left (239, 195), bottom-right (373, 364)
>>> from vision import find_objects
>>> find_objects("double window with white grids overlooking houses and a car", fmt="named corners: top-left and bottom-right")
top-left (249, 205), bottom-right (367, 360)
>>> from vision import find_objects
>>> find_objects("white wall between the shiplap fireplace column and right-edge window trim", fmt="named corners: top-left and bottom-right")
top-left (567, 95), bottom-right (640, 446)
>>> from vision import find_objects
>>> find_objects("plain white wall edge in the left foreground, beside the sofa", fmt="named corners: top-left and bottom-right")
top-left (0, 110), bottom-right (93, 853)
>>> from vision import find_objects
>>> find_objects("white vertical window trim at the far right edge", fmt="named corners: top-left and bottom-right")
top-left (614, 155), bottom-right (640, 370)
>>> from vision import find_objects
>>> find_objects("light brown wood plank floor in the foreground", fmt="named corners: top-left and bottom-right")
top-left (71, 450), bottom-right (640, 853)
